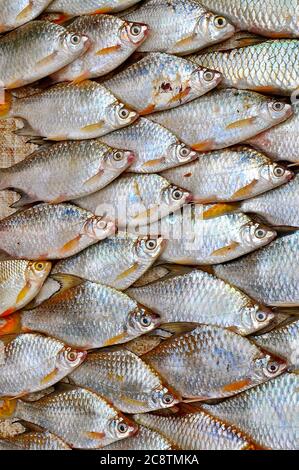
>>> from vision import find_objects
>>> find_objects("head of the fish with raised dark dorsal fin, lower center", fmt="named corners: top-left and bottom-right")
top-left (125, 304), bottom-right (161, 339)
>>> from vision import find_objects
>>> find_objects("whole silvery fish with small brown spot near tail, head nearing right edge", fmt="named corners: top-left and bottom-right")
top-left (162, 146), bottom-right (294, 204)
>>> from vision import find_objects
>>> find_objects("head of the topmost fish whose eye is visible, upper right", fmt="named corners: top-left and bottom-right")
top-left (199, 12), bottom-right (235, 44)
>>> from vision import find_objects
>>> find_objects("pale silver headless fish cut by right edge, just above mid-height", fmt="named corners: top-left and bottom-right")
top-left (241, 175), bottom-right (299, 228)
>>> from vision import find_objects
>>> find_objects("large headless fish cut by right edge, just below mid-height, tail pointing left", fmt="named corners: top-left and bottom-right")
top-left (214, 230), bottom-right (299, 307)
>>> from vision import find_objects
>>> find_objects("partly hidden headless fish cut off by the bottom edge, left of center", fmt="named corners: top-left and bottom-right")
top-left (103, 426), bottom-right (174, 451)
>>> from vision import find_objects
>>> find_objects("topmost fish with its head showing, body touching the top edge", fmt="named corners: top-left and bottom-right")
top-left (123, 0), bottom-right (235, 55)
